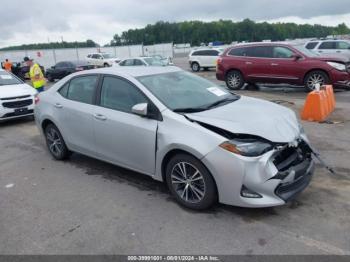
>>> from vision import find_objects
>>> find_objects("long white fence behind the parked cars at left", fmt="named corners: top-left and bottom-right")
top-left (0, 43), bottom-right (173, 68)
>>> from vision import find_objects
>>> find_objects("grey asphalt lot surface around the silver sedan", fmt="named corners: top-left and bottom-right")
top-left (0, 59), bottom-right (350, 254)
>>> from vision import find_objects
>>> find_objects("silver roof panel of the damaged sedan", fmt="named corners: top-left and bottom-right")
top-left (74, 66), bottom-right (183, 77)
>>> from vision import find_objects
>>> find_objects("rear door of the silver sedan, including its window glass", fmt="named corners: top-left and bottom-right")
top-left (54, 75), bottom-right (99, 156)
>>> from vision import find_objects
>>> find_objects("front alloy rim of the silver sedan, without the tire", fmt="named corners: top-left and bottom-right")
top-left (171, 162), bottom-right (206, 203)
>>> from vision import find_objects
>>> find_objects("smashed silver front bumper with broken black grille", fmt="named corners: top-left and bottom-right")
top-left (203, 139), bottom-right (315, 207)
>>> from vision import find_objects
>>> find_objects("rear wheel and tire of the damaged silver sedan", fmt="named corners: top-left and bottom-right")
top-left (45, 124), bottom-right (70, 160)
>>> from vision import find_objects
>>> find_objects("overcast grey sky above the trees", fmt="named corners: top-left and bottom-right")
top-left (0, 0), bottom-right (350, 47)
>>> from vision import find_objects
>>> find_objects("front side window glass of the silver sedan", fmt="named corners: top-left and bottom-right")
top-left (100, 76), bottom-right (148, 113)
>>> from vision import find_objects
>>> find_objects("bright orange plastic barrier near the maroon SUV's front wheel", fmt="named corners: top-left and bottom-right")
top-left (301, 91), bottom-right (328, 122)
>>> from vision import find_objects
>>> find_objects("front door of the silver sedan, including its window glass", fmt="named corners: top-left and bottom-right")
top-left (94, 76), bottom-right (158, 175)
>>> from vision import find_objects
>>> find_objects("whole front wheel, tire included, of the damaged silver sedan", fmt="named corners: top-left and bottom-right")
top-left (166, 154), bottom-right (217, 210)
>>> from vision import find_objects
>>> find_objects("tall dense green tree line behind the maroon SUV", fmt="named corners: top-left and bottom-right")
top-left (110, 19), bottom-right (350, 46)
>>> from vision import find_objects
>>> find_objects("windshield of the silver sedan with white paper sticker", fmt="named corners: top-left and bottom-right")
top-left (137, 71), bottom-right (238, 112)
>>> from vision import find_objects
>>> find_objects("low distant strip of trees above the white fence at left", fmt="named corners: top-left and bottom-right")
top-left (0, 39), bottom-right (99, 50)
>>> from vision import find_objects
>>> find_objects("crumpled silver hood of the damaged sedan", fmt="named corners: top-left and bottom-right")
top-left (186, 96), bottom-right (300, 143)
